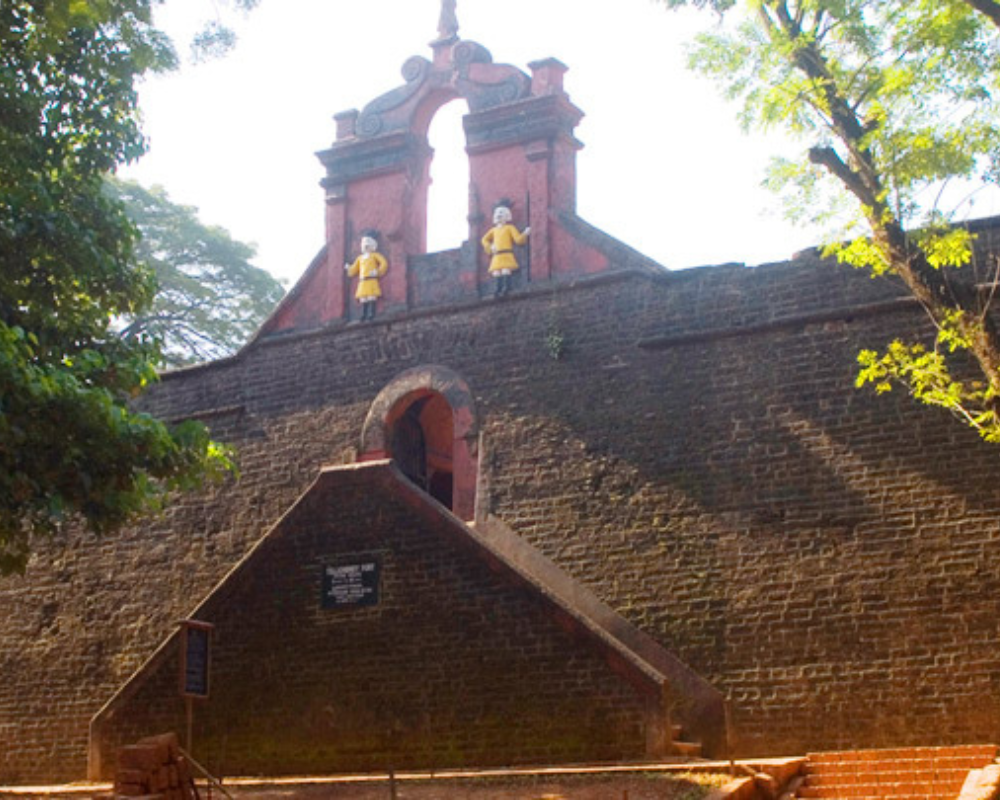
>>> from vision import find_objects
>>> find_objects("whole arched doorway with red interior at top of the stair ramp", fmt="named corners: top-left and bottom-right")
top-left (358, 366), bottom-right (479, 520)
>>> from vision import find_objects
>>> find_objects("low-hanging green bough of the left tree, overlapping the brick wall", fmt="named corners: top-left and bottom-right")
top-left (0, 326), bottom-right (229, 573)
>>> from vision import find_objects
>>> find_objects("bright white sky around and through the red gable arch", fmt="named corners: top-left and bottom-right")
top-left (124, 0), bottom-right (844, 285)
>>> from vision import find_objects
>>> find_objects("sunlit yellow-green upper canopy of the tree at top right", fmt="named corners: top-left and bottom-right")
top-left (689, 0), bottom-right (1000, 219)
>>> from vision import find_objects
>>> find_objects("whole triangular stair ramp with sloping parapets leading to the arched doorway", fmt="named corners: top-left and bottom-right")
top-left (89, 461), bottom-right (723, 779)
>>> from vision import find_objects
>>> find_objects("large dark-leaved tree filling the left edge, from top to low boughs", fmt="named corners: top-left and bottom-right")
top-left (0, 0), bottom-right (229, 573)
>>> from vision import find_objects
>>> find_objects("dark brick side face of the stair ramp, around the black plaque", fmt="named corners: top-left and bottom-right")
top-left (92, 468), bottom-right (645, 775)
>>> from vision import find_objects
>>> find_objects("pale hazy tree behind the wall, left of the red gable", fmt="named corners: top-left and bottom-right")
top-left (109, 180), bottom-right (284, 366)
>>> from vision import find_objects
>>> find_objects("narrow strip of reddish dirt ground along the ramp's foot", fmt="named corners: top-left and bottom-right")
top-left (225, 773), bottom-right (728, 800)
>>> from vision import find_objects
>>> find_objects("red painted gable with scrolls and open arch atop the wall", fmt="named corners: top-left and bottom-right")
top-left (261, 38), bottom-right (609, 335)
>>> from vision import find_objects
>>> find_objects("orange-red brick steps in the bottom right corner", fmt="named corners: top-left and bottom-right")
top-left (787, 745), bottom-right (998, 800)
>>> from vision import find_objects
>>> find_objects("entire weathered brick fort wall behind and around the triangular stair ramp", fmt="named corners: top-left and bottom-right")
top-left (0, 239), bottom-right (1000, 780)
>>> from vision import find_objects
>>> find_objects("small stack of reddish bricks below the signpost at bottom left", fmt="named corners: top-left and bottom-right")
top-left (115, 733), bottom-right (198, 800)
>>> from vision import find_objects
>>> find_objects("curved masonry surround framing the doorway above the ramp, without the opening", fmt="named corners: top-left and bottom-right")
top-left (358, 365), bottom-right (479, 520)
